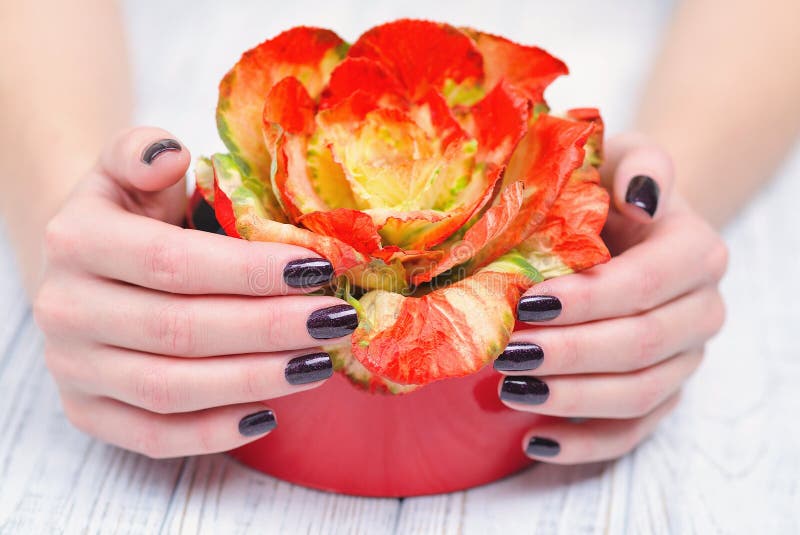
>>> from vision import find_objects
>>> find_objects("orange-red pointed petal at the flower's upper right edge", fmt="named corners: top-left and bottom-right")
top-left (463, 28), bottom-right (569, 103)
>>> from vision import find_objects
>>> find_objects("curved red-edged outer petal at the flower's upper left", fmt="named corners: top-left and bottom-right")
top-left (217, 27), bottom-right (346, 218)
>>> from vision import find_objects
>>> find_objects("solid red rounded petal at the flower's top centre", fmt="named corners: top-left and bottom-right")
top-left (348, 19), bottom-right (483, 100)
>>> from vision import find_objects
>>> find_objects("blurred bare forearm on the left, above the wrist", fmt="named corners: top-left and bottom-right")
top-left (0, 0), bottom-right (132, 291)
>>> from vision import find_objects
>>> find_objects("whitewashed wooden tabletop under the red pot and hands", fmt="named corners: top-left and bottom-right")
top-left (0, 144), bottom-right (800, 535)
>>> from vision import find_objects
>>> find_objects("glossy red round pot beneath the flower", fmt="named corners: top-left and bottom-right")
top-left (232, 366), bottom-right (544, 496)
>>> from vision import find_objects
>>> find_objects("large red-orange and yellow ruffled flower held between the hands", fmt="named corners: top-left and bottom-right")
top-left (191, 20), bottom-right (609, 393)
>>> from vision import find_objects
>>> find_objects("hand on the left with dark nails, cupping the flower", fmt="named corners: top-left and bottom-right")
top-left (34, 128), bottom-right (357, 457)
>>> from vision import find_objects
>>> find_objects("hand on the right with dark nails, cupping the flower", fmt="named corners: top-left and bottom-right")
top-left (495, 136), bottom-right (727, 464)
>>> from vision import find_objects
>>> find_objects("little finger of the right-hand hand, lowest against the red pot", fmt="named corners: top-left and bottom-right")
top-left (522, 394), bottom-right (680, 464)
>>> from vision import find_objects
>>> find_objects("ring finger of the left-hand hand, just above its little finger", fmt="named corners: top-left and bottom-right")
top-left (46, 346), bottom-right (333, 414)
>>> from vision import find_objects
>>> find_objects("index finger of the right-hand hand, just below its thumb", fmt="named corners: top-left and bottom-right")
top-left (517, 213), bottom-right (727, 325)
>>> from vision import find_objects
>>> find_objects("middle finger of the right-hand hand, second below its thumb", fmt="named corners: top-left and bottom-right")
top-left (494, 286), bottom-right (725, 375)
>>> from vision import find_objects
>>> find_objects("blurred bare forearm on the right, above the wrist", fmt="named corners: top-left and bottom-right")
top-left (637, 0), bottom-right (800, 226)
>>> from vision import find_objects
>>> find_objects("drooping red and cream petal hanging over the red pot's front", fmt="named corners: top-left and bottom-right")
top-left (352, 255), bottom-right (539, 385)
